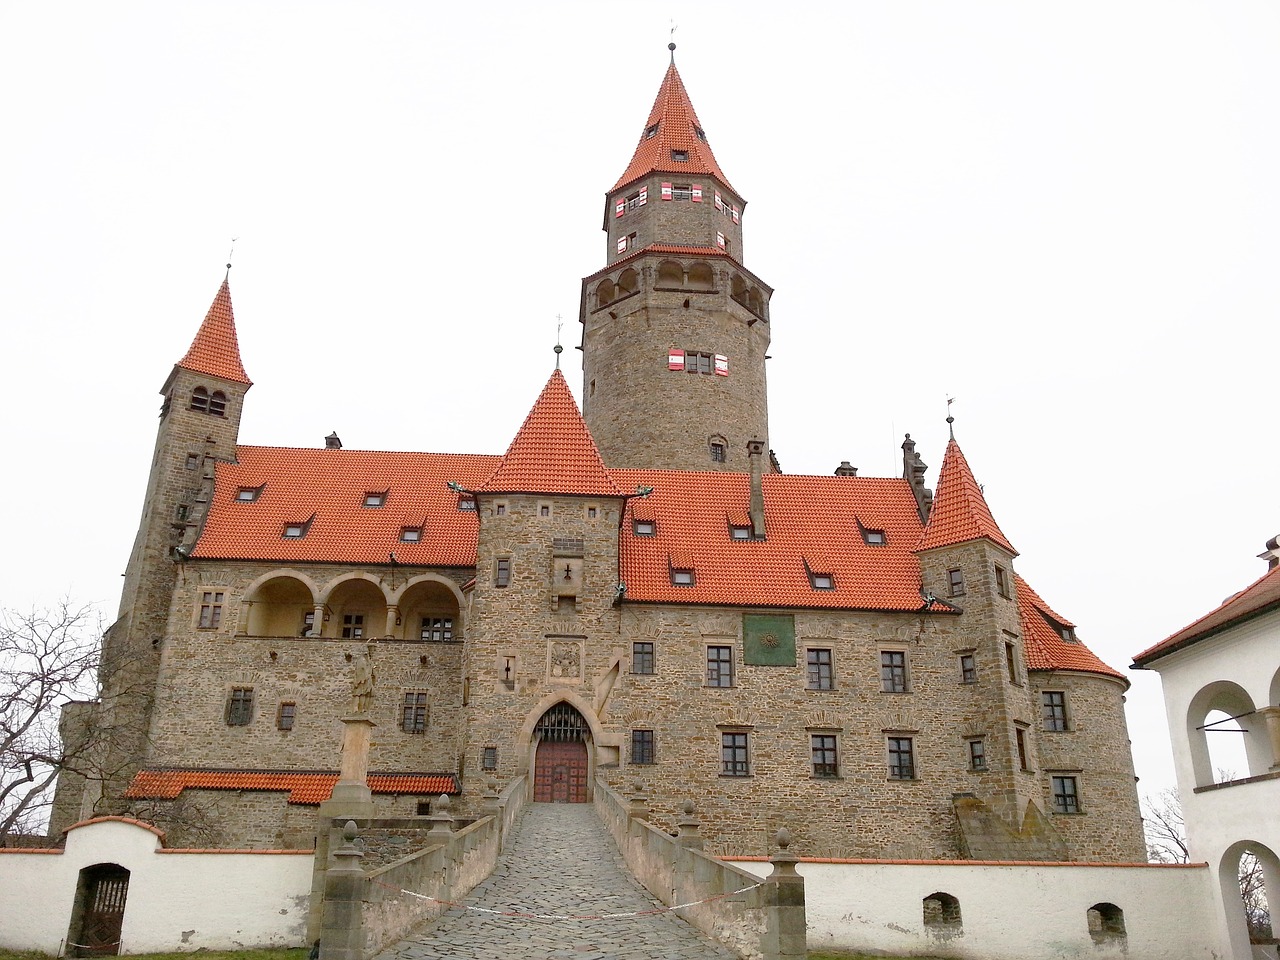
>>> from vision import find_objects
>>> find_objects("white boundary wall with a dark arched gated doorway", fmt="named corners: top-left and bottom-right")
top-left (0, 818), bottom-right (312, 954)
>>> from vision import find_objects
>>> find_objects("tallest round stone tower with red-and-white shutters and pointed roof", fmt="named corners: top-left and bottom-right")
top-left (579, 45), bottom-right (773, 472)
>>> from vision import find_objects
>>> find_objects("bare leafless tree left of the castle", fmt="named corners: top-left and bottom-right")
top-left (0, 599), bottom-right (101, 845)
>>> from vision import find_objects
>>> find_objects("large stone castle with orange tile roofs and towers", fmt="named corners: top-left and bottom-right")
top-left (51, 50), bottom-right (1146, 861)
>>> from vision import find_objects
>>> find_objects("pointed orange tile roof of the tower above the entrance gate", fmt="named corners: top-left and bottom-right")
top-left (477, 370), bottom-right (622, 497)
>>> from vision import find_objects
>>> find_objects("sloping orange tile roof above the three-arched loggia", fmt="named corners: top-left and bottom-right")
top-left (192, 447), bottom-right (498, 567)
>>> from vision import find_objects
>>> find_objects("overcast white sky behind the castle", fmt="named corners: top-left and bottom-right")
top-left (0, 0), bottom-right (1280, 788)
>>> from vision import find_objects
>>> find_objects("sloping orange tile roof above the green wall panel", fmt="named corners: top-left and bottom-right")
top-left (613, 470), bottom-right (947, 613)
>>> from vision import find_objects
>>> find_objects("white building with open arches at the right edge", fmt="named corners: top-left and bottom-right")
top-left (1134, 540), bottom-right (1280, 960)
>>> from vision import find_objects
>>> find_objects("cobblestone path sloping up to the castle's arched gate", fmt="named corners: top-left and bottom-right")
top-left (375, 804), bottom-right (735, 960)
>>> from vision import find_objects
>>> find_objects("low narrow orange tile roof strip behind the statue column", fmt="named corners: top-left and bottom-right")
top-left (124, 769), bottom-right (458, 806)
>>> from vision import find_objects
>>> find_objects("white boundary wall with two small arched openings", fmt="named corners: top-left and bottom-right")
top-left (726, 858), bottom-right (1226, 960)
